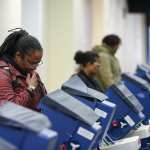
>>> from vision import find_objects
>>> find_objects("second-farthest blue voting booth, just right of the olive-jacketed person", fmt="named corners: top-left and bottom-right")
top-left (122, 73), bottom-right (150, 124)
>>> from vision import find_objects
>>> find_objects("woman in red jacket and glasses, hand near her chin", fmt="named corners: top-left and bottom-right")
top-left (0, 29), bottom-right (46, 111)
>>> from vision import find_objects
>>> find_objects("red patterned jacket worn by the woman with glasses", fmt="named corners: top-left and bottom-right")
top-left (0, 60), bottom-right (46, 110)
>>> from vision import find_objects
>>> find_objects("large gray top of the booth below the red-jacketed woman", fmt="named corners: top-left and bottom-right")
top-left (0, 102), bottom-right (51, 132)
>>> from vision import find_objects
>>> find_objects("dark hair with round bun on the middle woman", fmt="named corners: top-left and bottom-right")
top-left (74, 50), bottom-right (99, 65)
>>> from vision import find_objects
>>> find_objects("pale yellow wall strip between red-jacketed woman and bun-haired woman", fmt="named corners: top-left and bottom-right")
top-left (44, 0), bottom-right (74, 90)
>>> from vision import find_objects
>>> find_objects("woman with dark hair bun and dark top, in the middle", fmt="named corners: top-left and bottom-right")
top-left (74, 51), bottom-right (101, 91)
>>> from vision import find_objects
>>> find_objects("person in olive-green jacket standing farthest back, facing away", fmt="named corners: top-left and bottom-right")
top-left (92, 34), bottom-right (121, 91)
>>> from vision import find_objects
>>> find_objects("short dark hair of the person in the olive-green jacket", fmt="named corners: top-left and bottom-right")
top-left (102, 34), bottom-right (121, 47)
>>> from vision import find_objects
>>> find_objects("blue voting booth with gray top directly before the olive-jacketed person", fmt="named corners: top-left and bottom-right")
top-left (106, 82), bottom-right (145, 140)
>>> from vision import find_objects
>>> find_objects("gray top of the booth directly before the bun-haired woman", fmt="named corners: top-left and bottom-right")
top-left (62, 75), bottom-right (108, 101)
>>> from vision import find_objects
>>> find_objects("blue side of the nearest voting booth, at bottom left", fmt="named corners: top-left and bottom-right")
top-left (0, 126), bottom-right (56, 150)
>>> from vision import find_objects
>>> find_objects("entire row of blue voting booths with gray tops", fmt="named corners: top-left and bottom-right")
top-left (0, 65), bottom-right (150, 150)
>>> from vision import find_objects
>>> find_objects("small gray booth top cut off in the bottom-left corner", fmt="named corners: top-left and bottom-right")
top-left (0, 138), bottom-right (19, 150)
